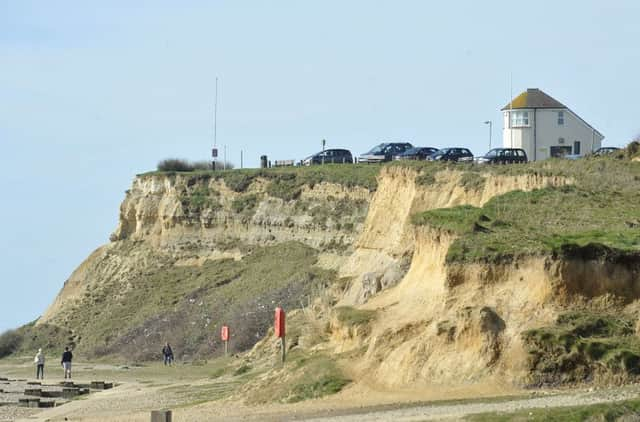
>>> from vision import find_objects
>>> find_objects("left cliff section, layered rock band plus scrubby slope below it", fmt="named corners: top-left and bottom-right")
top-left (38, 174), bottom-right (371, 359)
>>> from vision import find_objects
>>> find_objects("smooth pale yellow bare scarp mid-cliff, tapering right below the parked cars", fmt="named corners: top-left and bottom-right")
top-left (340, 167), bottom-right (571, 305)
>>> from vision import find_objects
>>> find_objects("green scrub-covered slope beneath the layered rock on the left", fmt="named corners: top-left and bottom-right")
top-left (31, 241), bottom-right (335, 360)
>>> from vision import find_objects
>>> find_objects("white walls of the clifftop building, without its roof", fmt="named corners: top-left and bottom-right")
top-left (502, 109), bottom-right (604, 161)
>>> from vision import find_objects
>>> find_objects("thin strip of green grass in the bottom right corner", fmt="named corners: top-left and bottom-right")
top-left (465, 400), bottom-right (640, 422)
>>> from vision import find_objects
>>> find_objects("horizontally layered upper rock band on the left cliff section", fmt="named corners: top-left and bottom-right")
top-left (112, 175), bottom-right (371, 248)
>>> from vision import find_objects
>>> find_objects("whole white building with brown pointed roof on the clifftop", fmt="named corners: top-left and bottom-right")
top-left (502, 88), bottom-right (604, 161)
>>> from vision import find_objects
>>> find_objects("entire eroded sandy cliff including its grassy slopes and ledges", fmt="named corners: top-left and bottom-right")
top-left (22, 158), bottom-right (640, 391)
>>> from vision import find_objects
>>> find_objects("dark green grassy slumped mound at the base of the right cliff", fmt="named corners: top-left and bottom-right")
top-left (522, 311), bottom-right (640, 385)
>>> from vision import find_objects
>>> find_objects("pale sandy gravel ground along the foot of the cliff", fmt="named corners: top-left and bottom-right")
top-left (5, 365), bottom-right (640, 422)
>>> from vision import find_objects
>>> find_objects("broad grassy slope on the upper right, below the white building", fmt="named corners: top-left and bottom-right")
top-left (413, 157), bottom-right (640, 262)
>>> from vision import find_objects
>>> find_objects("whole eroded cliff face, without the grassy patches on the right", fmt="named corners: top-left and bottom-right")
top-left (40, 166), bottom-right (640, 387)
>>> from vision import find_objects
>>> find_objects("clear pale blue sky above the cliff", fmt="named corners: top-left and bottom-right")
top-left (0, 0), bottom-right (640, 331)
